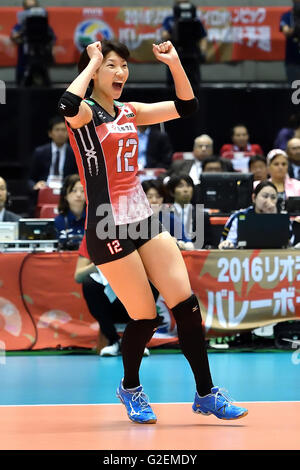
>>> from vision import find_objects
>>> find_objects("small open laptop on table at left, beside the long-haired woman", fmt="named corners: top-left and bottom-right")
top-left (19, 219), bottom-right (57, 240)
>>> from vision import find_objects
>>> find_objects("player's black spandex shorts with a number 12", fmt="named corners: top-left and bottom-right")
top-left (86, 214), bottom-right (166, 266)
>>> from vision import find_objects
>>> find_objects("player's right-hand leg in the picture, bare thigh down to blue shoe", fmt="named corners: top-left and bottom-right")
top-left (138, 232), bottom-right (247, 419)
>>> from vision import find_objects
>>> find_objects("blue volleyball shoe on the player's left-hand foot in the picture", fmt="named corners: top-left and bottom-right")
top-left (117, 380), bottom-right (157, 424)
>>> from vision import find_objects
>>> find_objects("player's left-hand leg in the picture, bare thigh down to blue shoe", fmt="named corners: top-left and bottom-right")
top-left (99, 251), bottom-right (159, 423)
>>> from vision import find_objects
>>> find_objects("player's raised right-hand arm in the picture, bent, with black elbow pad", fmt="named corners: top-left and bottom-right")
top-left (131, 41), bottom-right (198, 125)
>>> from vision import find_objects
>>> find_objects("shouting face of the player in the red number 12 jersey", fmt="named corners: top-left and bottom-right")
top-left (94, 51), bottom-right (129, 99)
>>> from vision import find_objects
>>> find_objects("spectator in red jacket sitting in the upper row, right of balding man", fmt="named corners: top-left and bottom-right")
top-left (220, 124), bottom-right (263, 172)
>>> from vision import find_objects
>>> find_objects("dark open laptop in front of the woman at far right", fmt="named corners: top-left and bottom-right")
top-left (238, 213), bottom-right (290, 249)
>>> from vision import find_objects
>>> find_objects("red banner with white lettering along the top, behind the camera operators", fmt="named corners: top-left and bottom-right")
top-left (0, 7), bottom-right (287, 67)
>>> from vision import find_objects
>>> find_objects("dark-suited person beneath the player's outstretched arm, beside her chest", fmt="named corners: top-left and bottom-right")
top-left (138, 126), bottom-right (172, 170)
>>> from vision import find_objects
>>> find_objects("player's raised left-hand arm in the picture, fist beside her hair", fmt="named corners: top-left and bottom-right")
top-left (59, 41), bottom-right (103, 129)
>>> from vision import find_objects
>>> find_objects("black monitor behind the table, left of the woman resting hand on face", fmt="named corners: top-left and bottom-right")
top-left (197, 173), bottom-right (253, 213)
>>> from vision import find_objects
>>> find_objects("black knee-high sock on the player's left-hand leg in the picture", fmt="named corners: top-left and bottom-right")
top-left (121, 316), bottom-right (161, 389)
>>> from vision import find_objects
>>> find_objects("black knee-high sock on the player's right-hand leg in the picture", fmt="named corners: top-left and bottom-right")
top-left (172, 294), bottom-right (213, 396)
